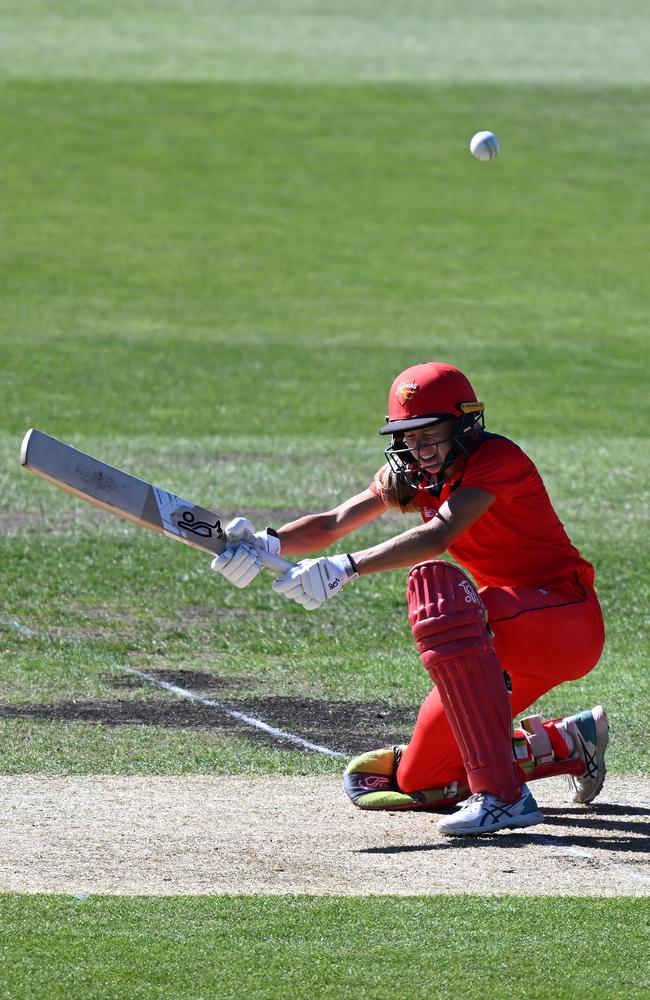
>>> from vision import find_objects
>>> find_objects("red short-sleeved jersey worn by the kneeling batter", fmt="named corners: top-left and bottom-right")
top-left (370, 433), bottom-right (594, 591)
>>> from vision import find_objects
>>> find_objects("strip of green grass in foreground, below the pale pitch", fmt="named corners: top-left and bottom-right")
top-left (0, 896), bottom-right (650, 1000)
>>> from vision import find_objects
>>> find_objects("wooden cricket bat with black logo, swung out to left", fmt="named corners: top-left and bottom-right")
top-left (20, 428), bottom-right (293, 573)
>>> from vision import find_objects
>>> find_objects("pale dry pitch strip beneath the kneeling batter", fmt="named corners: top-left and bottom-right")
top-left (0, 775), bottom-right (650, 896)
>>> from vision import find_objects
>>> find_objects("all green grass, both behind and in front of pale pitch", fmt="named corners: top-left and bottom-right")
top-left (0, 0), bottom-right (650, 1000)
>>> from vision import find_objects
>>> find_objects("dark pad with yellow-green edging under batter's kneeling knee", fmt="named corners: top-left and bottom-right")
top-left (343, 744), bottom-right (469, 812)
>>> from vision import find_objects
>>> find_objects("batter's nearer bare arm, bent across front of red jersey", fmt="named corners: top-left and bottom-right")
top-left (352, 487), bottom-right (495, 576)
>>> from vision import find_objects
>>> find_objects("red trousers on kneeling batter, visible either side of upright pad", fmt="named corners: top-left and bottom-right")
top-left (397, 580), bottom-right (605, 792)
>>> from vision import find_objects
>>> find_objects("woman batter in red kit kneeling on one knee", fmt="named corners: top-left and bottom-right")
top-left (212, 362), bottom-right (608, 835)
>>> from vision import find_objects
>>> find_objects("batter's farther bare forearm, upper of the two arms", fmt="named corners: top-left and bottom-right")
top-left (278, 490), bottom-right (386, 556)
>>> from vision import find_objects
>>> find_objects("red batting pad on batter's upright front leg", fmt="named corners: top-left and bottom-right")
top-left (407, 560), bottom-right (521, 802)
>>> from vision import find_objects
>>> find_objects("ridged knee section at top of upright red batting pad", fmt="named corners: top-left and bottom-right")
top-left (407, 559), bottom-right (492, 672)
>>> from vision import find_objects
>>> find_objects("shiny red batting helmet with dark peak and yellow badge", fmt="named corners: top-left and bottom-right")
top-left (379, 361), bottom-right (483, 434)
